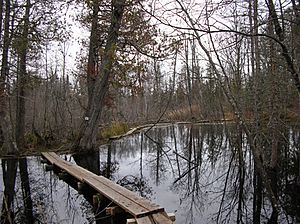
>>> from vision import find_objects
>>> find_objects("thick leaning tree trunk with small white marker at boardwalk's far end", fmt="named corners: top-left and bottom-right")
top-left (78, 0), bottom-right (126, 150)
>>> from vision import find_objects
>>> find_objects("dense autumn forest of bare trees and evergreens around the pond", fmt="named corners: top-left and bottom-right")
top-left (0, 0), bottom-right (300, 223)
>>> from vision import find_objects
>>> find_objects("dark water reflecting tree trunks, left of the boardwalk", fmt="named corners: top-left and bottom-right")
top-left (0, 157), bottom-right (94, 223)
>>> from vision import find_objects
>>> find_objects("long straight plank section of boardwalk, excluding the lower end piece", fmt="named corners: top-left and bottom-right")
top-left (42, 153), bottom-right (164, 218)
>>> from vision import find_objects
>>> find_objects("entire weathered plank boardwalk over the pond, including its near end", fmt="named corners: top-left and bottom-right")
top-left (42, 152), bottom-right (173, 224)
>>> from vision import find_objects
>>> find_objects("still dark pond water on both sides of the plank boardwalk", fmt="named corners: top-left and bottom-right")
top-left (0, 124), bottom-right (300, 224)
